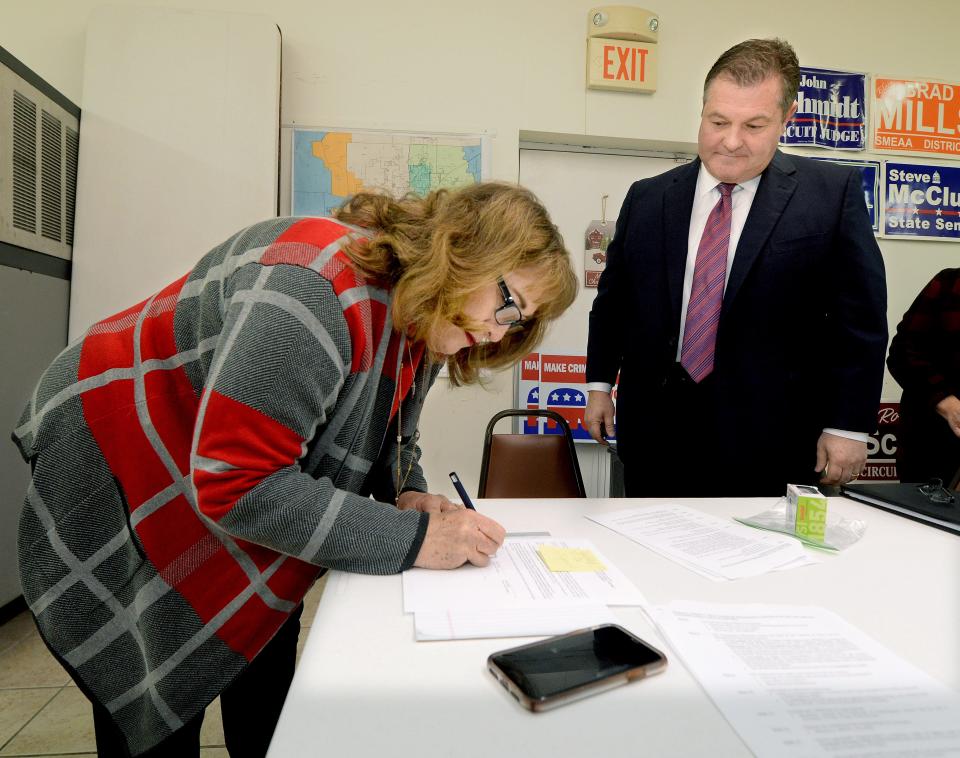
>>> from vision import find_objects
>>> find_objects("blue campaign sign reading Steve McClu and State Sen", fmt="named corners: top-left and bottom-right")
top-left (883, 162), bottom-right (960, 240)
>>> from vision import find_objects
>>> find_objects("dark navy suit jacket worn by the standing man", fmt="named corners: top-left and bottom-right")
top-left (587, 152), bottom-right (887, 496)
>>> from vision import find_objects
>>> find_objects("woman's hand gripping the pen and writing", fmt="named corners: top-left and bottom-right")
top-left (413, 508), bottom-right (507, 569)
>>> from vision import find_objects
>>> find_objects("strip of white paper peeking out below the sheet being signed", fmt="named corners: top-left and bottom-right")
top-left (413, 605), bottom-right (617, 641)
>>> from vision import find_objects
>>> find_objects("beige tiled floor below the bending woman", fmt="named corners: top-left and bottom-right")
top-left (0, 580), bottom-right (323, 758)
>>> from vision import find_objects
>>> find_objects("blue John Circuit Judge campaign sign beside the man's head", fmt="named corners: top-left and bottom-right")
top-left (780, 66), bottom-right (866, 150)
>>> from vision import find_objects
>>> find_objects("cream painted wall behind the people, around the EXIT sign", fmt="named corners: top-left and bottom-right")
top-left (0, 0), bottom-right (960, 498)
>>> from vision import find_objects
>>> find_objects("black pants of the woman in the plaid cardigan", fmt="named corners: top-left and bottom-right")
top-left (93, 605), bottom-right (303, 758)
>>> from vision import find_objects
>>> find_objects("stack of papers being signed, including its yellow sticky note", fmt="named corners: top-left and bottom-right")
top-left (403, 538), bottom-right (646, 640)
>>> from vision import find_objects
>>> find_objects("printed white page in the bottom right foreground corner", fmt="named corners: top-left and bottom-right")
top-left (654, 601), bottom-right (960, 758)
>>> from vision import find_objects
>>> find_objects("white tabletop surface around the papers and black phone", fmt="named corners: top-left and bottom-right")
top-left (269, 498), bottom-right (960, 758)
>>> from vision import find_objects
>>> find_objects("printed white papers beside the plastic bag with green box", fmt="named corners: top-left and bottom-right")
top-left (587, 505), bottom-right (818, 581)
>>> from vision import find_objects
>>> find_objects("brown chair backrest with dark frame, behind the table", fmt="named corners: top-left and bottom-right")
top-left (477, 408), bottom-right (587, 498)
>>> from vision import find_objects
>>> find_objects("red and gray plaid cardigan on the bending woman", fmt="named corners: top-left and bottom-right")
top-left (14, 219), bottom-right (439, 753)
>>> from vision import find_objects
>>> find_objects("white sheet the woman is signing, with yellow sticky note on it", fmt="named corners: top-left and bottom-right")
top-left (403, 527), bottom-right (648, 613)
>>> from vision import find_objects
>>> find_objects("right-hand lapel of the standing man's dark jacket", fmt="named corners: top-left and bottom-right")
top-left (723, 150), bottom-right (797, 311)
